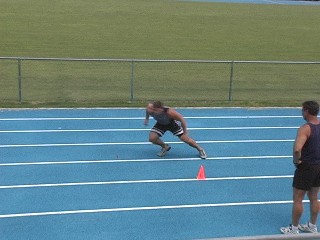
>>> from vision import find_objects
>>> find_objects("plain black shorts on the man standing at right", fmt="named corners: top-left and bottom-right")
top-left (292, 162), bottom-right (320, 191)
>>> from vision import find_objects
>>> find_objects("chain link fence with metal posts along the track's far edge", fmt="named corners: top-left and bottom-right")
top-left (0, 57), bottom-right (320, 103)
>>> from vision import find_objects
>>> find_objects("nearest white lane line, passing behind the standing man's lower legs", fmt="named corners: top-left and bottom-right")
top-left (0, 200), bottom-right (309, 218)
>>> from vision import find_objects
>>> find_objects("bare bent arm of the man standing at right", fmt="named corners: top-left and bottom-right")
top-left (293, 124), bottom-right (311, 165)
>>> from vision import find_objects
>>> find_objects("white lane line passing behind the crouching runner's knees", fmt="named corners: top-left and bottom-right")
top-left (0, 139), bottom-right (294, 148)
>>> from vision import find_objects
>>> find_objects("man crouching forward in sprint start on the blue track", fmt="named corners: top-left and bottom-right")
top-left (144, 101), bottom-right (207, 159)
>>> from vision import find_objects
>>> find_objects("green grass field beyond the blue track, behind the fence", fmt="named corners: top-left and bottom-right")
top-left (0, 0), bottom-right (320, 107)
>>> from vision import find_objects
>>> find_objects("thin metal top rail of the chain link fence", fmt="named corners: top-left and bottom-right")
top-left (0, 57), bottom-right (320, 64)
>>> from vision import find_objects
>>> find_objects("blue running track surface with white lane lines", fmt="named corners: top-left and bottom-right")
top-left (0, 108), bottom-right (308, 240)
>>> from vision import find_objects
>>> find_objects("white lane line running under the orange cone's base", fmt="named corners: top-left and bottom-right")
top-left (0, 175), bottom-right (293, 189)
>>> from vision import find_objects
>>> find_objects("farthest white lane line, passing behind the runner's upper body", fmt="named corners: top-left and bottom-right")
top-left (0, 115), bottom-right (301, 121)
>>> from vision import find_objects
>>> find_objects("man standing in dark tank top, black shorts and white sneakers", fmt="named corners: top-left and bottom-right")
top-left (280, 101), bottom-right (320, 234)
